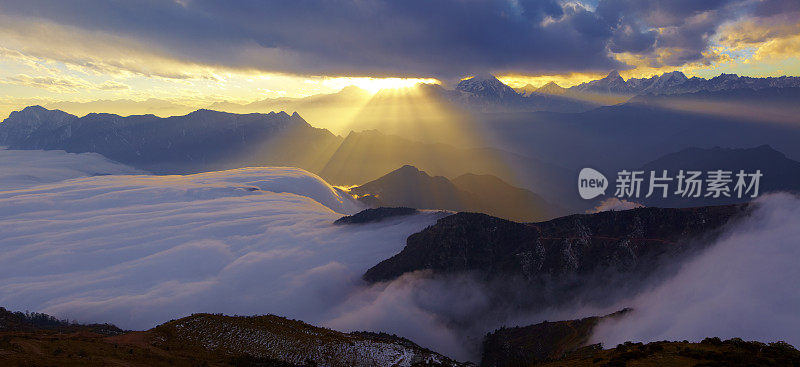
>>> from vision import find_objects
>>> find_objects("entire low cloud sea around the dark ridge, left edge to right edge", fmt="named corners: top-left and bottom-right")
top-left (0, 150), bottom-right (800, 361)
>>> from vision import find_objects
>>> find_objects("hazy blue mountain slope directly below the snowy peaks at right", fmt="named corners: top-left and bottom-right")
top-left (481, 99), bottom-right (800, 181)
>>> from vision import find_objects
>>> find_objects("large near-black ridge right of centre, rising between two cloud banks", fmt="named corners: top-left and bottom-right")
top-left (364, 205), bottom-right (747, 307)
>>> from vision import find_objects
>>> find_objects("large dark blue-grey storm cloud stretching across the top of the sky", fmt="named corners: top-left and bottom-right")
top-left (0, 0), bottom-right (780, 78)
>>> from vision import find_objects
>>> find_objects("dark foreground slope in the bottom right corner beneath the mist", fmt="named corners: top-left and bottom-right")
top-left (480, 309), bottom-right (800, 367)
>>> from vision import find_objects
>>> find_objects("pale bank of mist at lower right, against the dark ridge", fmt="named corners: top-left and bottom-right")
top-left (593, 194), bottom-right (800, 347)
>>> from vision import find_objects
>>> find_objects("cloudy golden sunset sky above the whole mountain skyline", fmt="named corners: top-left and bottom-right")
top-left (0, 0), bottom-right (800, 117)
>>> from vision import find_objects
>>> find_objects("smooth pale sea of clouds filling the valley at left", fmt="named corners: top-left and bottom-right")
top-left (0, 150), bottom-right (454, 344)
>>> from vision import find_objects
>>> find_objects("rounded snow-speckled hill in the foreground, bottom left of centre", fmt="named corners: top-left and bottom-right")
top-left (152, 314), bottom-right (460, 367)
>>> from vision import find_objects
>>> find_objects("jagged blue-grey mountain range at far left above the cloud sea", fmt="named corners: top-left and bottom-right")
top-left (0, 107), bottom-right (340, 173)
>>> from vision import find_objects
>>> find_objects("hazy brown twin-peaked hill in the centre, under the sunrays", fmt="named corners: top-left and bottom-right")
top-left (350, 165), bottom-right (558, 221)
